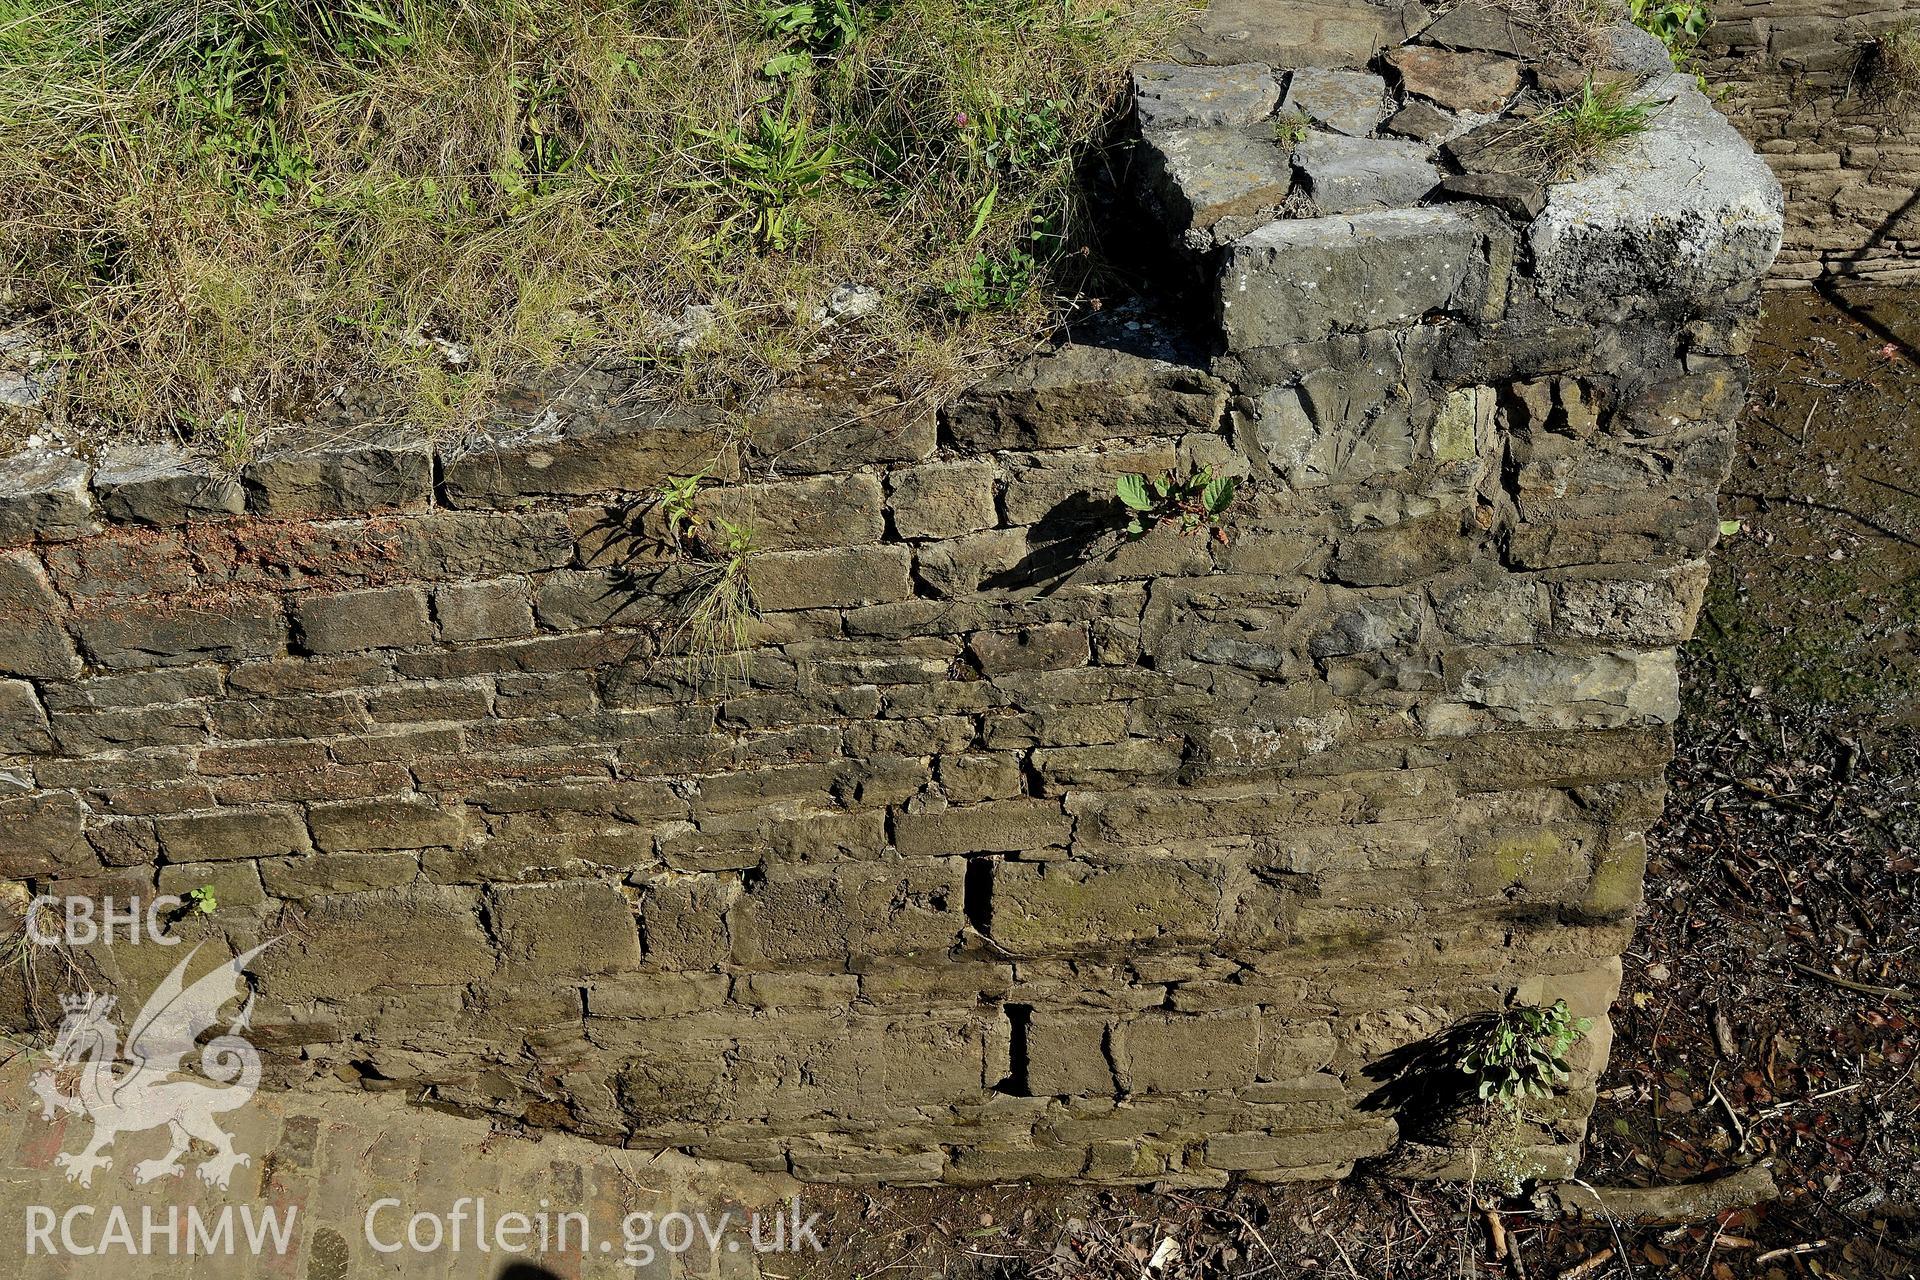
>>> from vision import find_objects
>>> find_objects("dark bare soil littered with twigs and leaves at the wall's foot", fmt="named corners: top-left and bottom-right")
top-left (793, 290), bottom-right (1920, 1280)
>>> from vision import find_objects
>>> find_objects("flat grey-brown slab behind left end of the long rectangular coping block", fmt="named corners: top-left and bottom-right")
top-left (1142, 125), bottom-right (1294, 236)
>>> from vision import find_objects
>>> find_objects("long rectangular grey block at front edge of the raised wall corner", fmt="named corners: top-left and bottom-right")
top-left (1219, 207), bottom-right (1478, 349)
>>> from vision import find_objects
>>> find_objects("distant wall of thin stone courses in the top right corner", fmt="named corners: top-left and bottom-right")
top-left (1701, 0), bottom-right (1920, 284)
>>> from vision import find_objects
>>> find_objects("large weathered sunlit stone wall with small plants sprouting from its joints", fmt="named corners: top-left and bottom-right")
top-left (0, 0), bottom-right (1780, 1184)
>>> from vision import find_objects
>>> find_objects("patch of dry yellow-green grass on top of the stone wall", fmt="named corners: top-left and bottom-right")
top-left (0, 0), bottom-right (1181, 462)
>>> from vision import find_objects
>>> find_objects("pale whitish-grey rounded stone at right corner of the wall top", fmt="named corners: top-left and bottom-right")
top-left (1530, 75), bottom-right (1786, 313)
